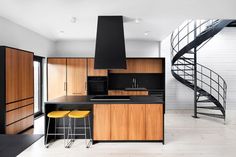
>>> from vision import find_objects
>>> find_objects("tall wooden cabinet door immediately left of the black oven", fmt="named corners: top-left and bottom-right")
top-left (67, 58), bottom-right (87, 95)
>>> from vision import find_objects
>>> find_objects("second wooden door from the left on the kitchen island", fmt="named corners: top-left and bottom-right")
top-left (111, 104), bottom-right (128, 140)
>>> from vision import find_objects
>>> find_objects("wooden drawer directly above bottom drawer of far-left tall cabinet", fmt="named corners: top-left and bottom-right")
top-left (6, 104), bottom-right (34, 125)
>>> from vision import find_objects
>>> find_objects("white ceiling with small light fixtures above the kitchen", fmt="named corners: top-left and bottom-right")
top-left (0, 0), bottom-right (236, 41)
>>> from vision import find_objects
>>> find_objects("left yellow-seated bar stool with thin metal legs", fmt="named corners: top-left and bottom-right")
top-left (46, 111), bottom-right (70, 148)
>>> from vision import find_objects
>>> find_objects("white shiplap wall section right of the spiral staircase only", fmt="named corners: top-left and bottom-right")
top-left (198, 27), bottom-right (236, 109)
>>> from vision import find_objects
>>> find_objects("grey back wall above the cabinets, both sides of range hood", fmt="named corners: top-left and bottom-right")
top-left (52, 40), bottom-right (160, 57)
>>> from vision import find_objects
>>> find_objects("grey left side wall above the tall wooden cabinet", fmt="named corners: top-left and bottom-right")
top-left (0, 17), bottom-right (54, 56)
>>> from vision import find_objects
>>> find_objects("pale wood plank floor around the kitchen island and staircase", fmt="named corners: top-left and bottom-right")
top-left (19, 110), bottom-right (236, 157)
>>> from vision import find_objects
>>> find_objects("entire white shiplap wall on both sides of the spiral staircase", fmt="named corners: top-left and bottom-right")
top-left (161, 28), bottom-right (236, 109)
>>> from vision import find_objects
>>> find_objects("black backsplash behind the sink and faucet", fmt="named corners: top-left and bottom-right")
top-left (108, 73), bottom-right (165, 90)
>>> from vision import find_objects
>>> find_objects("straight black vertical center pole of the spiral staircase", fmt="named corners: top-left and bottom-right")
top-left (193, 20), bottom-right (198, 118)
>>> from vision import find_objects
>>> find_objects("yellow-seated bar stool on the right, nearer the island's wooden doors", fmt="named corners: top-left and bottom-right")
top-left (67, 111), bottom-right (92, 148)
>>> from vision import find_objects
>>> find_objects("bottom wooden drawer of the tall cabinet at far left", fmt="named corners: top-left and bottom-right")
top-left (6, 115), bottom-right (34, 134)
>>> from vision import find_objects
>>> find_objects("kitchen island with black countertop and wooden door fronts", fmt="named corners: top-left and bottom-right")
top-left (45, 96), bottom-right (164, 144)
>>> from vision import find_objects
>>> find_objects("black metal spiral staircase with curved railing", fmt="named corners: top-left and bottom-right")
top-left (170, 20), bottom-right (234, 120)
